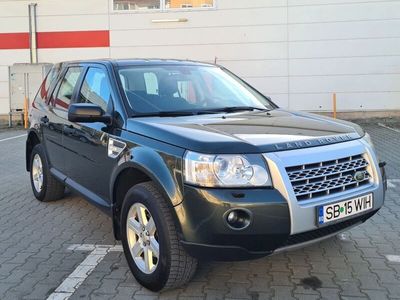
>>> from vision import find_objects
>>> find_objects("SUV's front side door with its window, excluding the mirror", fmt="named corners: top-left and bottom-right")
top-left (63, 66), bottom-right (115, 200)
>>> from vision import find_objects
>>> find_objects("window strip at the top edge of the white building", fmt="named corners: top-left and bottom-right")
top-left (113, 0), bottom-right (215, 10)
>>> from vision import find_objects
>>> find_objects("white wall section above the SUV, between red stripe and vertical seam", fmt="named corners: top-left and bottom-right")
top-left (110, 0), bottom-right (289, 107)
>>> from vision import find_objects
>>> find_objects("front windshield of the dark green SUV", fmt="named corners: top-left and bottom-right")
top-left (118, 65), bottom-right (275, 116)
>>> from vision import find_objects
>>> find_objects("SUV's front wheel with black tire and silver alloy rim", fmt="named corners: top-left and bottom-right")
top-left (121, 182), bottom-right (197, 292)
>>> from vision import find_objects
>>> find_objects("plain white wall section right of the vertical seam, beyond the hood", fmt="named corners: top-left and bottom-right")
top-left (288, 0), bottom-right (400, 110)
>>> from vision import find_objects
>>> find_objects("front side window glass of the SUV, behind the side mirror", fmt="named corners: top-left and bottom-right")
top-left (78, 68), bottom-right (111, 111)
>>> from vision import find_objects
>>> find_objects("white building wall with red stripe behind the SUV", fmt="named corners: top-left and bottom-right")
top-left (0, 0), bottom-right (400, 114)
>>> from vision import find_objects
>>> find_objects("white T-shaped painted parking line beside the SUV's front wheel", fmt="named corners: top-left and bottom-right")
top-left (47, 244), bottom-right (122, 300)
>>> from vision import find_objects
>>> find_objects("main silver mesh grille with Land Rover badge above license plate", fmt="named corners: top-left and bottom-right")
top-left (286, 154), bottom-right (371, 201)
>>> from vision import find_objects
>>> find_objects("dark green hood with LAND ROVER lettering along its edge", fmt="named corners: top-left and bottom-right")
top-left (127, 109), bottom-right (364, 154)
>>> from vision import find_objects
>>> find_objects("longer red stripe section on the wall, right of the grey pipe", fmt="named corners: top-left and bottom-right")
top-left (37, 30), bottom-right (110, 48)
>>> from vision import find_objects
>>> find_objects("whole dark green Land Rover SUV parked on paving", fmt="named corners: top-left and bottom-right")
top-left (26, 60), bottom-right (385, 291)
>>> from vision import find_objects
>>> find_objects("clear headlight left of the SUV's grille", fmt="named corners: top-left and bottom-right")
top-left (184, 151), bottom-right (271, 187)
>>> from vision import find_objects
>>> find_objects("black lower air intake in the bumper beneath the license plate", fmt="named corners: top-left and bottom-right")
top-left (282, 211), bottom-right (377, 247)
